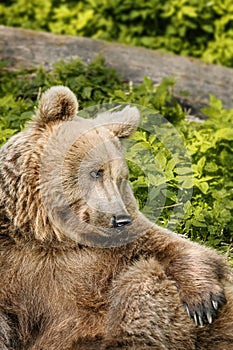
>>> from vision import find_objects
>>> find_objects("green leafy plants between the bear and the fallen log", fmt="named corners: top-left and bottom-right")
top-left (0, 57), bottom-right (233, 259)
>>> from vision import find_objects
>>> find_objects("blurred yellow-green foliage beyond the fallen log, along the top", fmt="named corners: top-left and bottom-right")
top-left (0, 0), bottom-right (233, 67)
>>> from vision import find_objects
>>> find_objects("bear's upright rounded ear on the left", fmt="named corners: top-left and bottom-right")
top-left (35, 85), bottom-right (78, 124)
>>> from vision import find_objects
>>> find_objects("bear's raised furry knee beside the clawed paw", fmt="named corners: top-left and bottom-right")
top-left (103, 258), bottom-right (195, 350)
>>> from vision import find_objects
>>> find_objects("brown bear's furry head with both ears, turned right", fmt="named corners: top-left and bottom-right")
top-left (0, 86), bottom-right (152, 247)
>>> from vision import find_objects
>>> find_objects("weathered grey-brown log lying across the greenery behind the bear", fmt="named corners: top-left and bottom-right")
top-left (0, 26), bottom-right (233, 108)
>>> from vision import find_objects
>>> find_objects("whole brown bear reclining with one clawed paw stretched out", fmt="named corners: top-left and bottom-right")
top-left (0, 86), bottom-right (233, 350)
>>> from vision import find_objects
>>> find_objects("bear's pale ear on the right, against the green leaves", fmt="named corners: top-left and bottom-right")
top-left (96, 106), bottom-right (140, 138)
